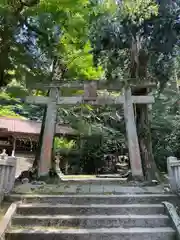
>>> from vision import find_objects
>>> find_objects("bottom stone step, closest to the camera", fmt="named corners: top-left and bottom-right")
top-left (6, 228), bottom-right (175, 240)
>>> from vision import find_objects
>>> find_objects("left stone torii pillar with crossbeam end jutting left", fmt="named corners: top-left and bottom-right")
top-left (26, 87), bottom-right (59, 177)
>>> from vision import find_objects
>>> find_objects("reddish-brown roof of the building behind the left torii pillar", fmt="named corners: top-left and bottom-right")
top-left (0, 117), bottom-right (76, 135)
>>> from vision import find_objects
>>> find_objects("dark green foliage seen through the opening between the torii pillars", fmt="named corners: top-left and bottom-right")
top-left (59, 104), bottom-right (127, 174)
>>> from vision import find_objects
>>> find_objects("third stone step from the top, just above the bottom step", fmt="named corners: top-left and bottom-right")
top-left (12, 215), bottom-right (171, 228)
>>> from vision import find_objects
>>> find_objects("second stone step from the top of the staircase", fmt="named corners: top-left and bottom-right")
top-left (17, 203), bottom-right (165, 215)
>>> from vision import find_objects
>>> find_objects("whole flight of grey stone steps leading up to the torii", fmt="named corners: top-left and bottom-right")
top-left (5, 193), bottom-right (177, 240)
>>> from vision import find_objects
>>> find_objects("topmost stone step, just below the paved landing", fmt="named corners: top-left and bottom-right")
top-left (7, 194), bottom-right (177, 205)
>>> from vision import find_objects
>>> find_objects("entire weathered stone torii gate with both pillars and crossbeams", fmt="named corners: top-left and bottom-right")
top-left (26, 81), bottom-right (154, 179)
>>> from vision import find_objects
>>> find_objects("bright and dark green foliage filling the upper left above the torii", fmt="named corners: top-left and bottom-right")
top-left (0, 0), bottom-right (101, 87)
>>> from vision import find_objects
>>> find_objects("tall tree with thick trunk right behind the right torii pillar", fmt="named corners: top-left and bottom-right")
top-left (90, 0), bottom-right (180, 179)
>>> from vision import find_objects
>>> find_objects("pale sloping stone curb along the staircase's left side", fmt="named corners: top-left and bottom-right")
top-left (0, 201), bottom-right (22, 240)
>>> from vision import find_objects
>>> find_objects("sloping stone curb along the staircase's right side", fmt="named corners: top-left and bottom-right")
top-left (162, 202), bottom-right (180, 240)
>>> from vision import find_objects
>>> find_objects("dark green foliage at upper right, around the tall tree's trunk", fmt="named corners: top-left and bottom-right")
top-left (90, 0), bottom-right (180, 87)
